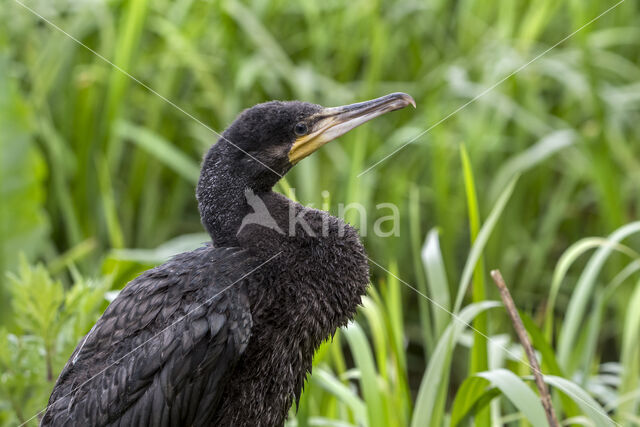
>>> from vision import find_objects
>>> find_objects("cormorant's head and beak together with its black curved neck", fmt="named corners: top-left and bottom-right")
top-left (196, 93), bottom-right (415, 245)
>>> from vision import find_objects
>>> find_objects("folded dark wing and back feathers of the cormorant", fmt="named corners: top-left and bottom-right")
top-left (42, 246), bottom-right (252, 426)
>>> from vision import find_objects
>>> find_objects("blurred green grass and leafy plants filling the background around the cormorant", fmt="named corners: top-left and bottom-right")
top-left (0, 0), bottom-right (640, 426)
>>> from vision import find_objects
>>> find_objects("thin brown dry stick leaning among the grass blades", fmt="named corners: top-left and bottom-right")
top-left (491, 270), bottom-right (558, 427)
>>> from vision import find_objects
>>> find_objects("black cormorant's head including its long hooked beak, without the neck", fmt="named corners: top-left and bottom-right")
top-left (212, 93), bottom-right (415, 191)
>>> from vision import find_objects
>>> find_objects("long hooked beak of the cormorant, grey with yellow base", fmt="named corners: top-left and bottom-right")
top-left (289, 92), bottom-right (416, 165)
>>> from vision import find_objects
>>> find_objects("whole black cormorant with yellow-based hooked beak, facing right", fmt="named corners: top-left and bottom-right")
top-left (41, 93), bottom-right (415, 426)
